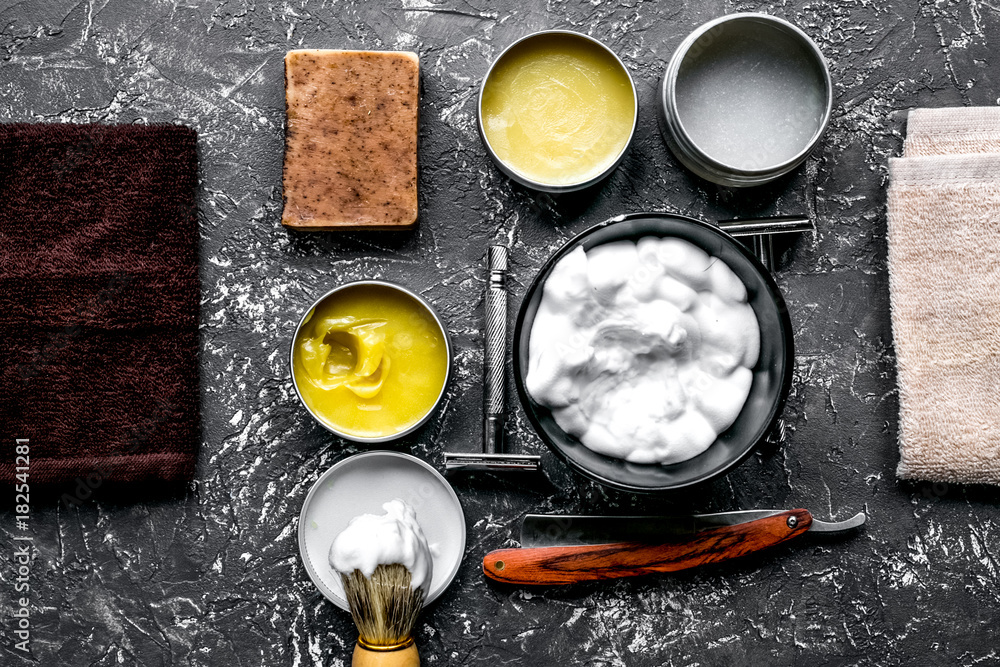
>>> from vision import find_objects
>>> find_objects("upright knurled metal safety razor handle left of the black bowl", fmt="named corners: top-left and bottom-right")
top-left (483, 245), bottom-right (507, 454)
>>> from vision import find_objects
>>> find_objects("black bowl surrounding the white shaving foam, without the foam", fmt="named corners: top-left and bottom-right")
top-left (514, 213), bottom-right (794, 492)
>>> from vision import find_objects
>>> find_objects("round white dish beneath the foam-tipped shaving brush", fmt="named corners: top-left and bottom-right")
top-left (298, 451), bottom-right (466, 610)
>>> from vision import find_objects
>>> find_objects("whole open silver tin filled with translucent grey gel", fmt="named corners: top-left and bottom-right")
top-left (659, 13), bottom-right (833, 187)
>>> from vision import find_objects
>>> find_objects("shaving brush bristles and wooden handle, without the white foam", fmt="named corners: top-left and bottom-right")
top-left (340, 563), bottom-right (424, 667)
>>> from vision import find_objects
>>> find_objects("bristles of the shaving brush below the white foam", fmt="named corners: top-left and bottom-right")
top-left (340, 564), bottom-right (424, 646)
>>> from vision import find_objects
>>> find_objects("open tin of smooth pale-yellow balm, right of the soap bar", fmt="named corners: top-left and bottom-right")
top-left (480, 32), bottom-right (636, 186)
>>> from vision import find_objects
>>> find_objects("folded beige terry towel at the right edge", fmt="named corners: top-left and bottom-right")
top-left (888, 108), bottom-right (1000, 484)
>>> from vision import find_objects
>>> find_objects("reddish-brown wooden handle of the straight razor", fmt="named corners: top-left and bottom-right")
top-left (483, 509), bottom-right (812, 586)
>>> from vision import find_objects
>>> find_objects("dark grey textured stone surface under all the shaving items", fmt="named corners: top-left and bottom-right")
top-left (0, 0), bottom-right (1000, 667)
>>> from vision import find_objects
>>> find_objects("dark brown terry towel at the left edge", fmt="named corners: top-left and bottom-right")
top-left (0, 124), bottom-right (200, 488)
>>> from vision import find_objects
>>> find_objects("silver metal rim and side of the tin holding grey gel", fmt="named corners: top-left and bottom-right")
top-left (660, 12), bottom-right (833, 185)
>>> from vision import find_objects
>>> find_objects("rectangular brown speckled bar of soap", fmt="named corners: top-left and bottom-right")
top-left (281, 50), bottom-right (420, 231)
